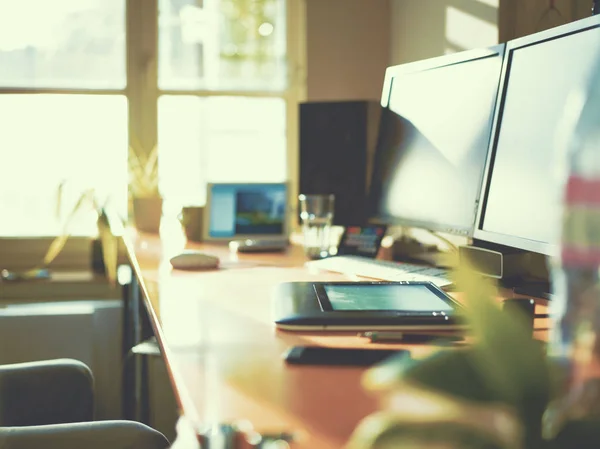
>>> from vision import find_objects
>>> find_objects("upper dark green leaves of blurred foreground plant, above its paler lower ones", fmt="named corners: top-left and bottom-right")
top-left (364, 263), bottom-right (550, 448)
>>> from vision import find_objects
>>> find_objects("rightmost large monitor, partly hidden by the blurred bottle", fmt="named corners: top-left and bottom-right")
top-left (474, 16), bottom-right (600, 255)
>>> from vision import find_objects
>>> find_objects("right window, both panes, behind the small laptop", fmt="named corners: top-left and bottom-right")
top-left (158, 0), bottom-right (289, 214)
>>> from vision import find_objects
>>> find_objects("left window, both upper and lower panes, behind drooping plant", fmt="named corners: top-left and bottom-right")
top-left (0, 0), bottom-right (127, 237)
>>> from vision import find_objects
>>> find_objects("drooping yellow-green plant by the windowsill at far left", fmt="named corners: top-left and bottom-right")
top-left (1, 181), bottom-right (118, 284)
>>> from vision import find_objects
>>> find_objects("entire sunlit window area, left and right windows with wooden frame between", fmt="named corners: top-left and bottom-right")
top-left (0, 0), bottom-right (303, 245)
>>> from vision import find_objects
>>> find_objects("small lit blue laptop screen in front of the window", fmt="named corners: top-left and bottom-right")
top-left (204, 183), bottom-right (288, 240)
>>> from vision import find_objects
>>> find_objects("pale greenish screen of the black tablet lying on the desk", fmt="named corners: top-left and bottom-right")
top-left (323, 283), bottom-right (454, 312)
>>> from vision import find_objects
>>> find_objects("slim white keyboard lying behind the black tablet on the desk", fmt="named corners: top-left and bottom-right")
top-left (306, 256), bottom-right (452, 287)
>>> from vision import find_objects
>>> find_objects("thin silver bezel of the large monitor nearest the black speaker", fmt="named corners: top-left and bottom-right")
top-left (369, 44), bottom-right (506, 237)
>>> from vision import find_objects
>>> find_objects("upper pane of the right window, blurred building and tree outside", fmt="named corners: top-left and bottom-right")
top-left (159, 0), bottom-right (286, 91)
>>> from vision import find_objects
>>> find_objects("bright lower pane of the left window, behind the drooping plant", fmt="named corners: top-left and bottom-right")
top-left (0, 95), bottom-right (127, 236)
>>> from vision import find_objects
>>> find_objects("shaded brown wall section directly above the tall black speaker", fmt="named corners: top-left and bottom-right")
top-left (306, 0), bottom-right (392, 101)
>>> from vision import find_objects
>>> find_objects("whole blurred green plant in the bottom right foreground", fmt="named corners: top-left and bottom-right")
top-left (348, 260), bottom-right (600, 449)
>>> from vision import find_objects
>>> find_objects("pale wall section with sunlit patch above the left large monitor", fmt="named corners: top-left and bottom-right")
top-left (390, 0), bottom-right (500, 64)
